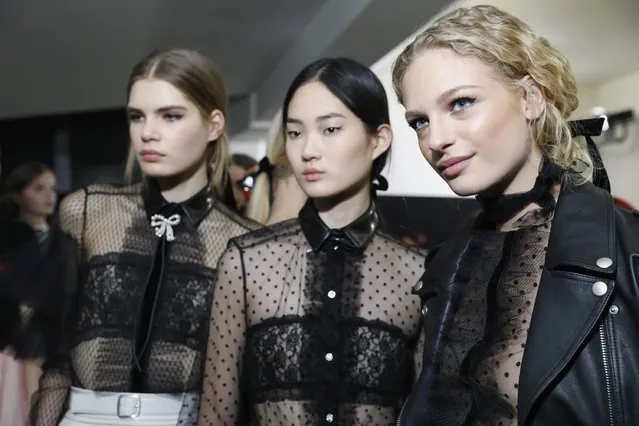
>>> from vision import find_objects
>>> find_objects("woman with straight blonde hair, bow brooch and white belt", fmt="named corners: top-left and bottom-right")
top-left (31, 49), bottom-right (259, 426)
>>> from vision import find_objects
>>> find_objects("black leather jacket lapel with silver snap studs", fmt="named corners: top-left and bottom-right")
top-left (518, 184), bottom-right (617, 425)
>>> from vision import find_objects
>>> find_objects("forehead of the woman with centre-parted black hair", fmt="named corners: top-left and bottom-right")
top-left (288, 81), bottom-right (352, 120)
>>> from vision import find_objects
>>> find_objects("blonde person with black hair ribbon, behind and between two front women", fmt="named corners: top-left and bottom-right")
top-left (243, 111), bottom-right (307, 225)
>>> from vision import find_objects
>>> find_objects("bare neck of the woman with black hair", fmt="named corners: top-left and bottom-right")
top-left (313, 185), bottom-right (371, 229)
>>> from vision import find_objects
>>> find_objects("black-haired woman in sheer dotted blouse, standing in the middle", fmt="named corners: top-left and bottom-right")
top-left (199, 59), bottom-right (424, 426)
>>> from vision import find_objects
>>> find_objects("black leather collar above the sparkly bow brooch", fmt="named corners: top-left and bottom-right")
top-left (142, 179), bottom-right (216, 226)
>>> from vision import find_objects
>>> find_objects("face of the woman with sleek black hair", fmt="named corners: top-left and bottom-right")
top-left (285, 81), bottom-right (392, 199)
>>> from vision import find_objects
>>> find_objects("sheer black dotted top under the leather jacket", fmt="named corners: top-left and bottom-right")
top-left (424, 162), bottom-right (563, 426)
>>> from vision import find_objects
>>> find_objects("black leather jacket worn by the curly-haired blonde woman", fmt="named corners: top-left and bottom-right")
top-left (397, 184), bottom-right (639, 426)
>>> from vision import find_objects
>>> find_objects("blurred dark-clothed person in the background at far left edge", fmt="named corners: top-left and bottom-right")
top-left (0, 162), bottom-right (75, 425)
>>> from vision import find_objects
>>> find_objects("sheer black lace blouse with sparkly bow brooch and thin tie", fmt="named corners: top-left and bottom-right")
top-left (32, 181), bottom-right (259, 425)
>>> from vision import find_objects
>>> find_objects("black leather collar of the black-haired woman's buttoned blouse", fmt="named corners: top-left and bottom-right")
top-left (298, 200), bottom-right (380, 251)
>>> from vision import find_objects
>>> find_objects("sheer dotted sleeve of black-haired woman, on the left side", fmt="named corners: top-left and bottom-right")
top-left (198, 241), bottom-right (246, 426)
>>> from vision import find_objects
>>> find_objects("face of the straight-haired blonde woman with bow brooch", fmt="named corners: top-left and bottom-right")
top-left (127, 79), bottom-right (224, 178)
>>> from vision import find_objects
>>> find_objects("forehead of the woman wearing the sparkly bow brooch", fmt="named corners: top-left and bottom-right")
top-left (129, 78), bottom-right (191, 109)
